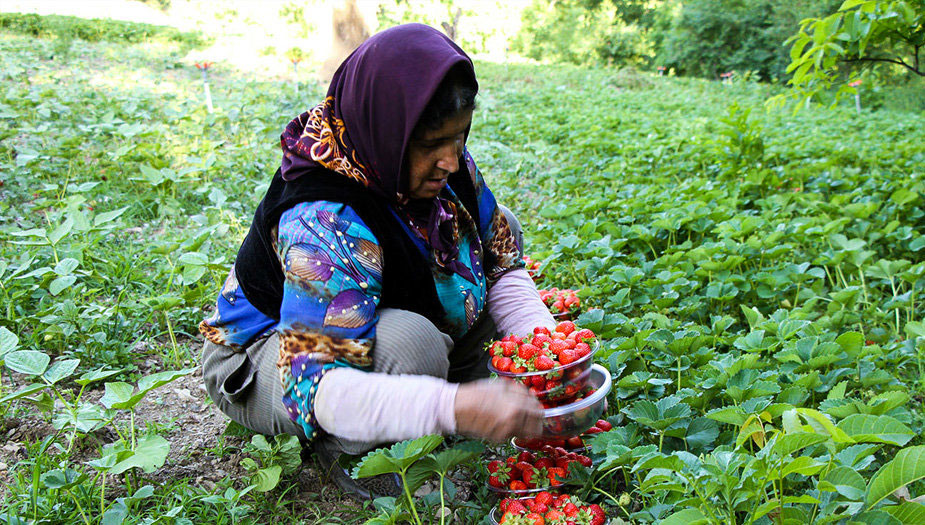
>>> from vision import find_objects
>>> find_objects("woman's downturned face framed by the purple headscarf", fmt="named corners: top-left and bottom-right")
top-left (408, 109), bottom-right (472, 199)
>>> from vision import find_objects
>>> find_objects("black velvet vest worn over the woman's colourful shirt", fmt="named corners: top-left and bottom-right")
top-left (235, 167), bottom-right (485, 328)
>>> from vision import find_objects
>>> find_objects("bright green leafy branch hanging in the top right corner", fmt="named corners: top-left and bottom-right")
top-left (787, 0), bottom-right (925, 107)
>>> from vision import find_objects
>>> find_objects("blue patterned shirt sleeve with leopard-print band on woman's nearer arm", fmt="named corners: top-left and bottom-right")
top-left (276, 201), bottom-right (382, 439)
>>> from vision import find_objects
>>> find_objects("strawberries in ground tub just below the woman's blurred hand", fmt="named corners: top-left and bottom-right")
top-left (487, 447), bottom-right (591, 492)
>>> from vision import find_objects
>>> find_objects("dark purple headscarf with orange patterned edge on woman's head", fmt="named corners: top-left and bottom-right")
top-left (281, 24), bottom-right (477, 205)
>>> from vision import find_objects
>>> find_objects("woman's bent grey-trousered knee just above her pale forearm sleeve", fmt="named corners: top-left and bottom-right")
top-left (373, 308), bottom-right (453, 378)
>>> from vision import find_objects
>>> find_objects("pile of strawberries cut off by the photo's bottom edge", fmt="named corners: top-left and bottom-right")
top-left (498, 491), bottom-right (607, 525)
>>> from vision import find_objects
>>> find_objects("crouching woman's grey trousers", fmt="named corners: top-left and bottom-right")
top-left (202, 207), bottom-right (523, 454)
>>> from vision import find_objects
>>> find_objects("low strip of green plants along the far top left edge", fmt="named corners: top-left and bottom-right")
top-left (0, 13), bottom-right (205, 48)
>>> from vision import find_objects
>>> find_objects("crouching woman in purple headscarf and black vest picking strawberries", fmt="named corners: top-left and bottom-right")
top-left (200, 24), bottom-right (554, 496)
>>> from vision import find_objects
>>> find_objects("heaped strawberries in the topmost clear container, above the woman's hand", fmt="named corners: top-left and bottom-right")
top-left (489, 321), bottom-right (595, 408)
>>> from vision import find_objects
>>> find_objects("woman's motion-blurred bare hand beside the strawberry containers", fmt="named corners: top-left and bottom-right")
top-left (455, 379), bottom-right (543, 443)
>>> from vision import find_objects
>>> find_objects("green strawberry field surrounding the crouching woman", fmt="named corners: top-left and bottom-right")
top-left (0, 16), bottom-right (925, 524)
